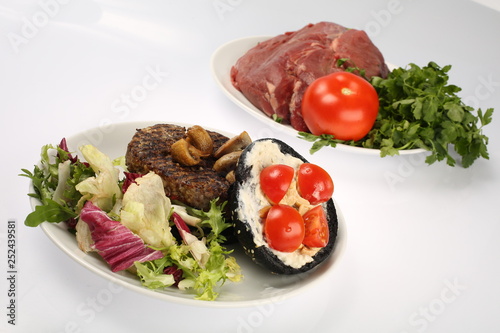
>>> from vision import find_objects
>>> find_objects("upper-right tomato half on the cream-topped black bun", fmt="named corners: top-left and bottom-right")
top-left (297, 163), bottom-right (333, 205)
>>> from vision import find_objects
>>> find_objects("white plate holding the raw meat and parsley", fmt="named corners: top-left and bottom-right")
top-left (211, 36), bottom-right (426, 155)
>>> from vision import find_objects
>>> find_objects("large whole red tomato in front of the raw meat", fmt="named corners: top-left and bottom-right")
top-left (302, 72), bottom-right (379, 141)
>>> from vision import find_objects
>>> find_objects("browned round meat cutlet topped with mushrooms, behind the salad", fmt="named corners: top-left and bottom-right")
top-left (125, 124), bottom-right (229, 209)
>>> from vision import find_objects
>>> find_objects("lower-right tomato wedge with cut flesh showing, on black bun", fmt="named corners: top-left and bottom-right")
top-left (302, 206), bottom-right (330, 247)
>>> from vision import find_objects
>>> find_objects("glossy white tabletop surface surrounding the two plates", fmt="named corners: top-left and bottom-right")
top-left (0, 0), bottom-right (500, 333)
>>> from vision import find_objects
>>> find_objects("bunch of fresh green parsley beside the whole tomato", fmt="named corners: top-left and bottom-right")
top-left (299, 62), bottom-right (493, 168)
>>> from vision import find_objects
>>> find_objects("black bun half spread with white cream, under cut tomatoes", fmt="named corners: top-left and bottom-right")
top-left (229, 138), bottom-right (338, 275)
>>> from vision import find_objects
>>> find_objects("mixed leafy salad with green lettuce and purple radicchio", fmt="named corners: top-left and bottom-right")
top-left (20, 139), bottom-right (243, 301)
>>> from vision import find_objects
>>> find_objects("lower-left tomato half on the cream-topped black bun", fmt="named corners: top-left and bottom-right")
top-left (264, 205), bottom-right (305, 252)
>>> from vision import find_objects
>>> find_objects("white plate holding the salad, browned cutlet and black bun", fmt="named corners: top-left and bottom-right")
top-left (31, 122), bottom-right (346, 307)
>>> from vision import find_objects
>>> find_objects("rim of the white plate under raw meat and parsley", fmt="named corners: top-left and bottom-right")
top-left (210, 35), bottom-right (427, 155)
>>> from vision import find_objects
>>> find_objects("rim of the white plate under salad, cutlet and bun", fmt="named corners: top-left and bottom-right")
top-left (29, 121), bottom-right (347, 308)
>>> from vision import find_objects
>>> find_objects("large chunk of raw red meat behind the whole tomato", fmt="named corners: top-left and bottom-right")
top-left (231, 22), bottom-right (388, 132)
